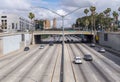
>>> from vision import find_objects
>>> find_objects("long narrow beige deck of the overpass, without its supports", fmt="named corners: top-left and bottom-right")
top-left (33, 30), bottom-right (94, 35)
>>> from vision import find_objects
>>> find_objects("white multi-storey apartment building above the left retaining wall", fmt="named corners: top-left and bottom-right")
top-left (0, 13), bottom-right (34, 31)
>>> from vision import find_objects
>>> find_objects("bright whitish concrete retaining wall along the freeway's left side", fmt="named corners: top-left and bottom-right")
top-left (0, 33), bottom-right (31, 55)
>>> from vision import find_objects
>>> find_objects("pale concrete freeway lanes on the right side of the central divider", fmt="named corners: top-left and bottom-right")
top-left (65, 44), bottom-right (120, 82)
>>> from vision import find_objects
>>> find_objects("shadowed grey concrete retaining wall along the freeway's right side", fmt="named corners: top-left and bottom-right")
top-left (98, 33), bottom-right (120, 51)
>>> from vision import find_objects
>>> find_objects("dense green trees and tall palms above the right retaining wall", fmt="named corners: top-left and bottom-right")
top-left (75, 6), bottom-right (119, 31)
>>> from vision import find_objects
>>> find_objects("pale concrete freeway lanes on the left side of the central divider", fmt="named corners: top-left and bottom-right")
top-left (0, 45), bottom-right (61, 82)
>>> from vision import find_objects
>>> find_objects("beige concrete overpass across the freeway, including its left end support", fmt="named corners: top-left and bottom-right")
top-left (32, 30), bottom-right (94, 44)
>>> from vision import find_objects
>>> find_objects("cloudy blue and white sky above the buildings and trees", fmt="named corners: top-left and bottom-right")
top-left (0, 0), bottom-right (120, 27)
